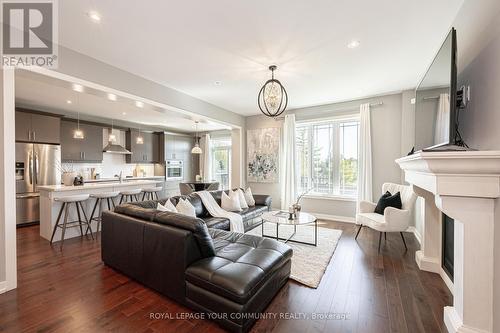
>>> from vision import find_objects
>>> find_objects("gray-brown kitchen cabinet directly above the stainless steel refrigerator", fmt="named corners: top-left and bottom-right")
top-left (15, 111), bottom-right (61, 144)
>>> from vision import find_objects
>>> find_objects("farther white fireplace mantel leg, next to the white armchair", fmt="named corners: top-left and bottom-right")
top-left (413, 186), bottom-right (441, 273)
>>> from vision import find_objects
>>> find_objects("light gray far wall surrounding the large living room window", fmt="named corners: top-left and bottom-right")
top-left (245, 93), bottom-right (411, 219)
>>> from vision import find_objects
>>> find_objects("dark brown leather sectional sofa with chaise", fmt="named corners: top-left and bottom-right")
top-left (101, 191), bottom-right (292, 332)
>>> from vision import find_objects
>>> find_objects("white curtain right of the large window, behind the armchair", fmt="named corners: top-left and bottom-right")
top-left (358, 103), bottom-right (372, 208)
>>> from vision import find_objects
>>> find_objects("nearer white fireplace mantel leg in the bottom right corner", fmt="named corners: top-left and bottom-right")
top-left (436, 196), bottom-right (498, 333)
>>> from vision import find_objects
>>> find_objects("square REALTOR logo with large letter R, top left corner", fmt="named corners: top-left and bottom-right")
top-left (1, 0), bottom-right (57, 68)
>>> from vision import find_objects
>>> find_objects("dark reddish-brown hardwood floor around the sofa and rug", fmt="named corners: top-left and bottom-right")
top-left (0, 222), bottom-right (452, 333)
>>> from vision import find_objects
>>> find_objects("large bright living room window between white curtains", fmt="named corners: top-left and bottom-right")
top-left (296, 119), bottom-right (359, 197)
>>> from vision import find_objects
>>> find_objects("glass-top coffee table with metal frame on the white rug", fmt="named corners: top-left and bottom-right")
top-left (262, 210), bottom-right (318, 246)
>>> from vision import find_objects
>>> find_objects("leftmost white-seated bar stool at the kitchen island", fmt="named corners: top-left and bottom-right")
top-left (50, 194), bottom-right (94, 249)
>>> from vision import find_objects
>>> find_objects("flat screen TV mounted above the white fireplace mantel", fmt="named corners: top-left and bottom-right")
top-left (415, 29), bottom-right (457, 151)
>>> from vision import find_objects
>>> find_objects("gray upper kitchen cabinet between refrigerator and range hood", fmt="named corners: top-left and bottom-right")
top-left (61, 121), bottom-right (103, 162)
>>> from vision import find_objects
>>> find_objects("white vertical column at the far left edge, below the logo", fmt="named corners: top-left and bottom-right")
top-left (0, 69), bottom-right (17, 294)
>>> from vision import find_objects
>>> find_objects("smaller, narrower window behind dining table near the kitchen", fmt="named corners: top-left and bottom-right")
top-left (211, 137), bottom-right (231, 190)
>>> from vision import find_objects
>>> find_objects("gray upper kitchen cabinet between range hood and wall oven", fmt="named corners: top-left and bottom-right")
top-left (126, 129), bottom-right (160, 163)
